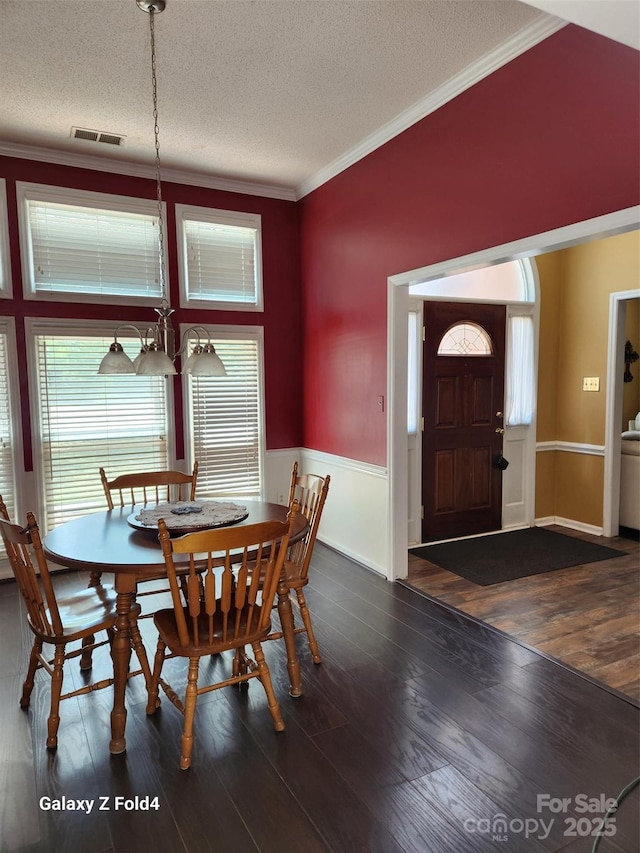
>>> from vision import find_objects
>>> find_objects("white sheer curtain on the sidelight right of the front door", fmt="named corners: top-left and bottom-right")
top-left (506, 317), bottom-right (535, 426)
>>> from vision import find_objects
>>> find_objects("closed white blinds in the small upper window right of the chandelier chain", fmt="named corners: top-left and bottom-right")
top-left (183, 218), bottom-right (258, 304)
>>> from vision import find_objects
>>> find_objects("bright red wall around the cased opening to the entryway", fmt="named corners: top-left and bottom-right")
top-left (301, 26), bottom-right (640, 465)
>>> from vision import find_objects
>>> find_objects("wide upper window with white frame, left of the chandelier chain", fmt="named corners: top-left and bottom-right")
top-left (17, 183), bottom-right (168, 304)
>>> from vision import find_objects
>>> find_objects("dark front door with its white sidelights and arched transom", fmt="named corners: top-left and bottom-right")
top-left (407, 259), bottom-right (538, 545)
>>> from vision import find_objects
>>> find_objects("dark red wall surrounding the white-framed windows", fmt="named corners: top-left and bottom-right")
top-left (0, 157), bottom-right (302, 470)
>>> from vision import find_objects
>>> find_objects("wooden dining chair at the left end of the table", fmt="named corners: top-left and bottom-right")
top-left (0, 496), bottom-right (150, 749)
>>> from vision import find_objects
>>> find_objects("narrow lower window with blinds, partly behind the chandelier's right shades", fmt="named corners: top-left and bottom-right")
top-left (186, 327), bottom-right (264, 498)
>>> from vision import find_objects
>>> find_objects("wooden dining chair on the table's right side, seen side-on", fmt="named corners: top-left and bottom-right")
top-left (267, 462), bottom-right (331, 697)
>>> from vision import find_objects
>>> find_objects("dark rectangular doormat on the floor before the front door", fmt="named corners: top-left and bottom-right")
top-left (410, 527), bottom-right (627, 586)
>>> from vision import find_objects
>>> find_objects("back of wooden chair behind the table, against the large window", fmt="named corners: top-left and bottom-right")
top-left (100, 462), bottom-right (198, 509)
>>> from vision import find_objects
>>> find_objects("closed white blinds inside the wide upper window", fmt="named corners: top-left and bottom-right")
top-left (25, 198), bottom-right (162, 297)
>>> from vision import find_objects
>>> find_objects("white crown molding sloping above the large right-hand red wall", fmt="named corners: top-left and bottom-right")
top-left (296, 15), bottom-right (567, 199)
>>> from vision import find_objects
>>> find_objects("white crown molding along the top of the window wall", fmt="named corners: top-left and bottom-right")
top-left (0, 140), bottom-right (297, 201)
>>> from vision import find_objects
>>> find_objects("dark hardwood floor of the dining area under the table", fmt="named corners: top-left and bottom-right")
top-left (0, 545), bottom-right (640, 853)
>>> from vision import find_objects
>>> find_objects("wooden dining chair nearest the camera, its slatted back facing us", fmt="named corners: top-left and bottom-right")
top-left (147, 502), bottom-right (298, 770)
